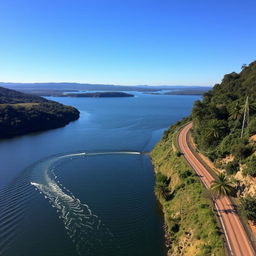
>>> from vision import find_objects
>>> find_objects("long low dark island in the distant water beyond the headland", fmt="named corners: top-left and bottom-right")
top-left (59, 92), bottom-right (134, 98)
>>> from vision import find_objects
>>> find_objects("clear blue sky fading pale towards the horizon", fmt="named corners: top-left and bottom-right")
top-left (0, 0), bottom-right (256, 85)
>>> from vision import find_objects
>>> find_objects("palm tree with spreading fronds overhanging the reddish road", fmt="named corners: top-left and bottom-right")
top-left (211, 173), bottom-right (235, 198)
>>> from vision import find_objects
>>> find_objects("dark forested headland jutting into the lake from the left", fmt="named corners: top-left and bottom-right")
top-left (0, 87), bottom-right (79, 138)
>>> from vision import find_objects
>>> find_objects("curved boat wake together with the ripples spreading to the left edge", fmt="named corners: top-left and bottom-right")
top-left (0, 152), bottom-right (140, 255)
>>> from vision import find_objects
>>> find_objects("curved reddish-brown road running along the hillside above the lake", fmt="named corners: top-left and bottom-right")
top-left (178, 123), bottom-right (256, 256)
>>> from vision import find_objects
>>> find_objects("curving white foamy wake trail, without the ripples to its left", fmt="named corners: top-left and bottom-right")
top-left (30, 152), bottom-right (140, 256)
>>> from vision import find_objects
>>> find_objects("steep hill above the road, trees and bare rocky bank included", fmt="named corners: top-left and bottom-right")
top-left (192, 61), bottom-right (256, 230)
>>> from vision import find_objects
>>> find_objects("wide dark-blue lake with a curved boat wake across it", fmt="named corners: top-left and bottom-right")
top-left (0, 92), bottom-right (200, 256)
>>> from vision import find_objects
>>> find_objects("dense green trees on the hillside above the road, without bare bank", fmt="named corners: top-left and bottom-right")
top-left (192, 61), bottom-right (256, 177)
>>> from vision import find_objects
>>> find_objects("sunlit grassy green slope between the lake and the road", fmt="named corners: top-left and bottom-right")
top-left (151, 120), bottom-right (224, 256)
